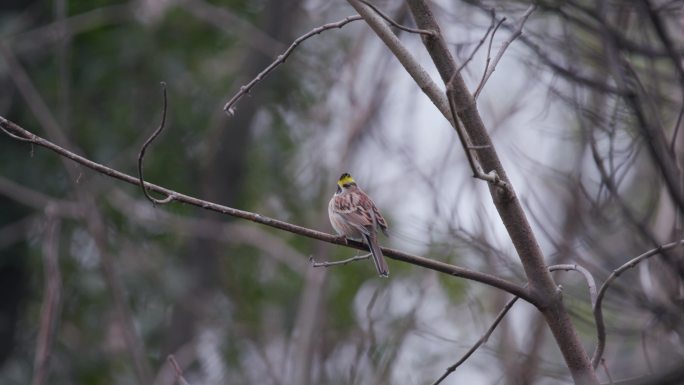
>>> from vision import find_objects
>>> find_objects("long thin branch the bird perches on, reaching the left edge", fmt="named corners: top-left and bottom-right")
top-left (0, 116), bottom-right (540, 306)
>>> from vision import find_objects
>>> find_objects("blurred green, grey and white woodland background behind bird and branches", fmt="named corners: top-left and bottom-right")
top-left (0, 0), bottom-right (684, 385)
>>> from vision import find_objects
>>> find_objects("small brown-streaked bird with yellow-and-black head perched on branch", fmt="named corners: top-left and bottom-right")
top-left (328, 173), bottom-right (389, 277)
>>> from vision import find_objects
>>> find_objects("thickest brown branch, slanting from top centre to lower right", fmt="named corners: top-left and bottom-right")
top-left (404, 0), bottom-right (599, 384)
